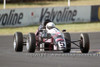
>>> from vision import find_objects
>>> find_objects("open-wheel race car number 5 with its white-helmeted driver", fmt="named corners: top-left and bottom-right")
top-left (14, 22), bottom-right (90, 53)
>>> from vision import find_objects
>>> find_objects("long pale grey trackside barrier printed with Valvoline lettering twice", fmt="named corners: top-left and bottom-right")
top-left (0, 6), bottom-right (91, 27)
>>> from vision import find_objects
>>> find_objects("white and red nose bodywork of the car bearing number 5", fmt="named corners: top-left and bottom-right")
top-left (47, 28), bottom-right (66, 50)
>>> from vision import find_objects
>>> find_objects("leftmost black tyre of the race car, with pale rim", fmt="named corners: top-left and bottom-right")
top-left (13, 32), bottom-right (23, 52)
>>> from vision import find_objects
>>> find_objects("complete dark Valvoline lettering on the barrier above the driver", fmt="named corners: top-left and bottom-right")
top-left (40, 7), bottom-right (77, 22)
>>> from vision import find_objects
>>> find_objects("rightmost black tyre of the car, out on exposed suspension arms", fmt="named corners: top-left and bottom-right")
top-left (80, 33), bottom-right (90, 53)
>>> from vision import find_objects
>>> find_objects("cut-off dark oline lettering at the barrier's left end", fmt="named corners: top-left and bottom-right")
top-left (0, 10), bottom-right (23, 26)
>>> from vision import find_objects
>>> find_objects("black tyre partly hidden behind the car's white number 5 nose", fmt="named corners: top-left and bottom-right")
top-left (63, 32), bottom-right (71, 53)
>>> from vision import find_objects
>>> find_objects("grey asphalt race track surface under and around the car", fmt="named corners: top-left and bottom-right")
top-left (0, 32), bottom-right (100, 67)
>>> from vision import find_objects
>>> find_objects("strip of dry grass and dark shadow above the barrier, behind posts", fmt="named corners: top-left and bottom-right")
top-left (0, 0), bottom-right (100, 9)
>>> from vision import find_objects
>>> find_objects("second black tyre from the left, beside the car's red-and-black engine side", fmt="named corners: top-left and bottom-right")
top-left (26, 33), bottom-right (36, 53)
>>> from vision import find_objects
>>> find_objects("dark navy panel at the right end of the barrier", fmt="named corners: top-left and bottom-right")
top-left (91, 5), bottom-right (100, 22)
